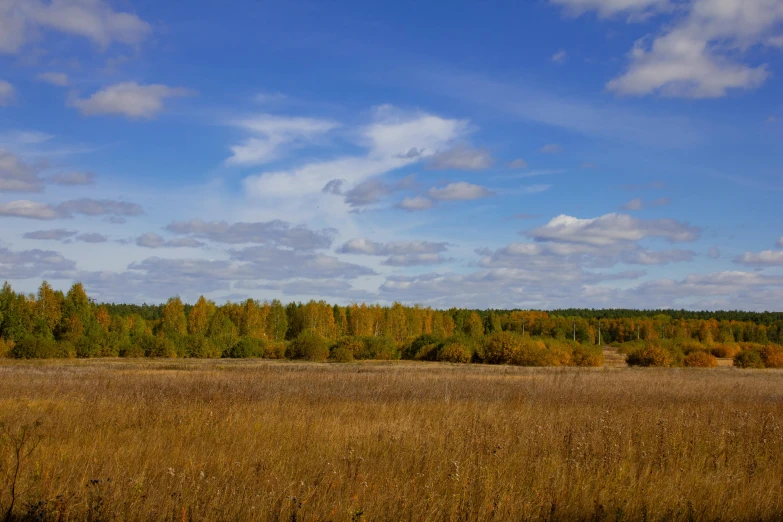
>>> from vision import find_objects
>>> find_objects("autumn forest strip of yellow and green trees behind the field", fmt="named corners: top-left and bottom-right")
top-left (0, 281), bottom-right (783, 368)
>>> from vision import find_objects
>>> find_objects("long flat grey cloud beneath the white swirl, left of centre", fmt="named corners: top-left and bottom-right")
top-left (166, 215), bottom-right (336, 250)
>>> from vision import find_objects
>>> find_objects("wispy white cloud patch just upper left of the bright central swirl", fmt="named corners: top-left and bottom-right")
top-left (226, 114), bottom-right (338, 165)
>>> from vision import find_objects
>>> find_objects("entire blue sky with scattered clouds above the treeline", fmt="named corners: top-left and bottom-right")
top-left (0, 0), bottom-right (783, 311)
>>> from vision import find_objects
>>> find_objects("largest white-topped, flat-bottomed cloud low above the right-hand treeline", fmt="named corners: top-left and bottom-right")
top-left (527, 213), bottom-right (701, 247)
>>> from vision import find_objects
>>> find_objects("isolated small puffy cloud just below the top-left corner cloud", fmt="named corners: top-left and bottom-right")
top-left (69, 82), bottom-right (191, 119)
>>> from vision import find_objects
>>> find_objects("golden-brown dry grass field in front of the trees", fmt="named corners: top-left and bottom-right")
top-left (0, 359), bottom-right (783, 521)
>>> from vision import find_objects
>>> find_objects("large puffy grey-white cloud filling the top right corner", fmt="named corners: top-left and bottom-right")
top-left (553, 0), bottom-right (783, 98)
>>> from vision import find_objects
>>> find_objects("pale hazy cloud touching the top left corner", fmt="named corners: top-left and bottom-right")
top-left (0, 0), bottom-right (150, 53)
